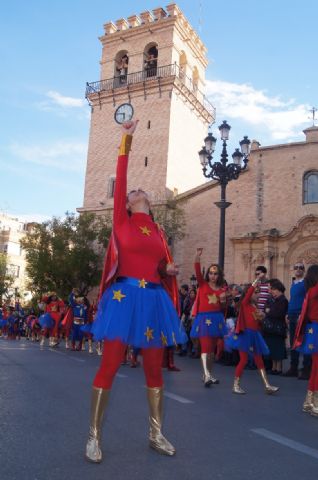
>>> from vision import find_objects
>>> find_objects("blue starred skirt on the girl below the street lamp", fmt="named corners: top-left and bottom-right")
top-left (190, 312), bottom-right (227, 338)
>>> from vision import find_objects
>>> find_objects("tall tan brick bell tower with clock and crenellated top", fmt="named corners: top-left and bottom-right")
top-left (79, 4), bottom-right (215, 212)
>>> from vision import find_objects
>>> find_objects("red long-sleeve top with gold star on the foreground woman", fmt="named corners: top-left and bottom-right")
top-left (113, 155), bottom-right (166, 283)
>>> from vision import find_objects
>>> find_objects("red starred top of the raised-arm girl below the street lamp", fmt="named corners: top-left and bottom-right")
top-left (194, 262), bottom-right (225, 313)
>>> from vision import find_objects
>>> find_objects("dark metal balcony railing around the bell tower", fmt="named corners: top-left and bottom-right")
top-left (86, 63), bottom-right (215, 119)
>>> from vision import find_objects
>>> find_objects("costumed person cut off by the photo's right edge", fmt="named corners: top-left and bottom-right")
top-left (294, 265), bottom-right (318, 417)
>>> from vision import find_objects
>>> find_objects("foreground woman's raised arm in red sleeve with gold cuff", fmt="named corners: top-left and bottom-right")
top-left (114, 120), bottom-right (138, 226)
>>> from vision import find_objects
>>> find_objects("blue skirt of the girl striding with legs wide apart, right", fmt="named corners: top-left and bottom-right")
top-left (224, 328), bottom-right (269, 355)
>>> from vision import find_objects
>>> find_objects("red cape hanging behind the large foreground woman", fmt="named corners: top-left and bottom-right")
top-left (98, 226), bottom-right (180, 313)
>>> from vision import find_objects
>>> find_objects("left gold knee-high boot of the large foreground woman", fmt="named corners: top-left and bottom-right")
top-left (85, 387), bottom-right (110, 463)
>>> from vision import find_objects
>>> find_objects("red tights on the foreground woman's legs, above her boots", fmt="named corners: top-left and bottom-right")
top-left (93, 340), bottom-right (163, 390)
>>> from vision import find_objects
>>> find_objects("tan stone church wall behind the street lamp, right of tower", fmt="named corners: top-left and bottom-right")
top-left (175, 127), bottom-right (318, 292)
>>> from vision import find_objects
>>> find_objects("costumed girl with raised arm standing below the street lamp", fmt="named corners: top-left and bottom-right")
top-left (190, 248), bottom-right (227, 387)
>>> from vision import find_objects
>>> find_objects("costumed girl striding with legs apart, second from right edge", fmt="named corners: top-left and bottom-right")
top-left (226, 279), bottom-right (278, 394)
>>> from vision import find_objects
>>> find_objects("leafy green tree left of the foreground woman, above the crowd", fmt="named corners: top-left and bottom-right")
top-left (20, 212), bottom-right (111, 297)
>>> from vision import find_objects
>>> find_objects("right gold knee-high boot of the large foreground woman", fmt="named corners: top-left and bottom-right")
top-left (147, 387), bottom-right (176, 455)
